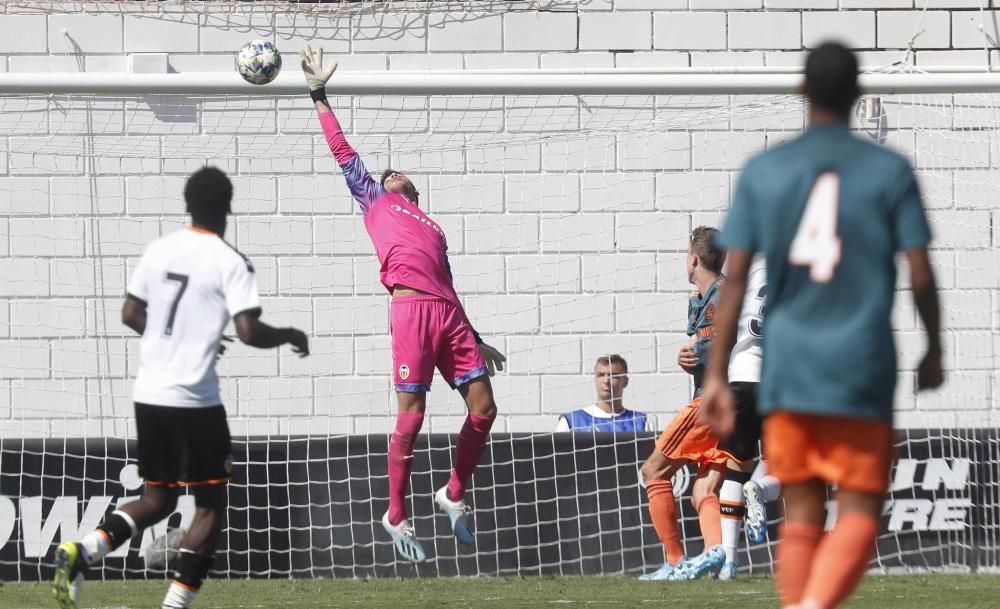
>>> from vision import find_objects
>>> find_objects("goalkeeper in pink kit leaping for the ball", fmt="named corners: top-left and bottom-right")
top-left (300, 47), bottom-right (506, 563)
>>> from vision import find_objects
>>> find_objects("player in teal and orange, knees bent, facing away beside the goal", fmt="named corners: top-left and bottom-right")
top-left (640, 226), bottom-right (729, 580)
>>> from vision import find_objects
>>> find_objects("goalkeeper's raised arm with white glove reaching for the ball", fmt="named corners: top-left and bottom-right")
top-left (299, 46), bottom-right (386, 213)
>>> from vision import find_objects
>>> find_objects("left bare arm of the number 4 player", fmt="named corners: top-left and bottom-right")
top-left (699, 250), bottom-right (753, 438)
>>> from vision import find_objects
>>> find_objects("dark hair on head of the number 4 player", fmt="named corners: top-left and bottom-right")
top-left (806, 42), bottom-right (861, 118)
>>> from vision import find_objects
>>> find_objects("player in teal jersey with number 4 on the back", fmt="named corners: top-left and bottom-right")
top-left (702, 44), bottom-right (943, 609)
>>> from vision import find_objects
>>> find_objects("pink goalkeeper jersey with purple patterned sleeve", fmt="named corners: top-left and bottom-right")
top-left (319, 112), bottom-right (462, 309)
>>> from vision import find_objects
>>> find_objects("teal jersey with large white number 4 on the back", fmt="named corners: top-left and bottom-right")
top-left (719, 124), bottom-right (930, 421)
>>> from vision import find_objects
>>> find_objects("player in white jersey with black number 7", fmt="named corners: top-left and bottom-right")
top-left (54, 167), bottom-right (309, 609)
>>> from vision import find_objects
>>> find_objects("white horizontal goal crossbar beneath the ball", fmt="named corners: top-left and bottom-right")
top-left (0, 66), bottom-right (1000, 97)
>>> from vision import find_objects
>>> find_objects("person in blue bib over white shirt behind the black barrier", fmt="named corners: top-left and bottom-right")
top-left (556, 354), bottom-right (646, 432)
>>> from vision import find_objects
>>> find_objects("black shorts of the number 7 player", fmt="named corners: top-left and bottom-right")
top-left (135, 402), bottom-right (233, 488)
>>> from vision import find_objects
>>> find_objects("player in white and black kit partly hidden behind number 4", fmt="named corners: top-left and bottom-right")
top-left (719, 255), bottom-right (781, 580)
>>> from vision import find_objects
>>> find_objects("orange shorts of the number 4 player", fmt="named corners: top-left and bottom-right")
top-left (764, 412), bottom-right (893, 494)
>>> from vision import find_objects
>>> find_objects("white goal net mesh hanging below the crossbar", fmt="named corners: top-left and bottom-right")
top-left (0, 84), bottom-right (1000, 579)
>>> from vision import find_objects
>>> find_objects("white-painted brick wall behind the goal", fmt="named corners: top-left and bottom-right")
top-left (0, 0), bottom-right (1000, 435)
